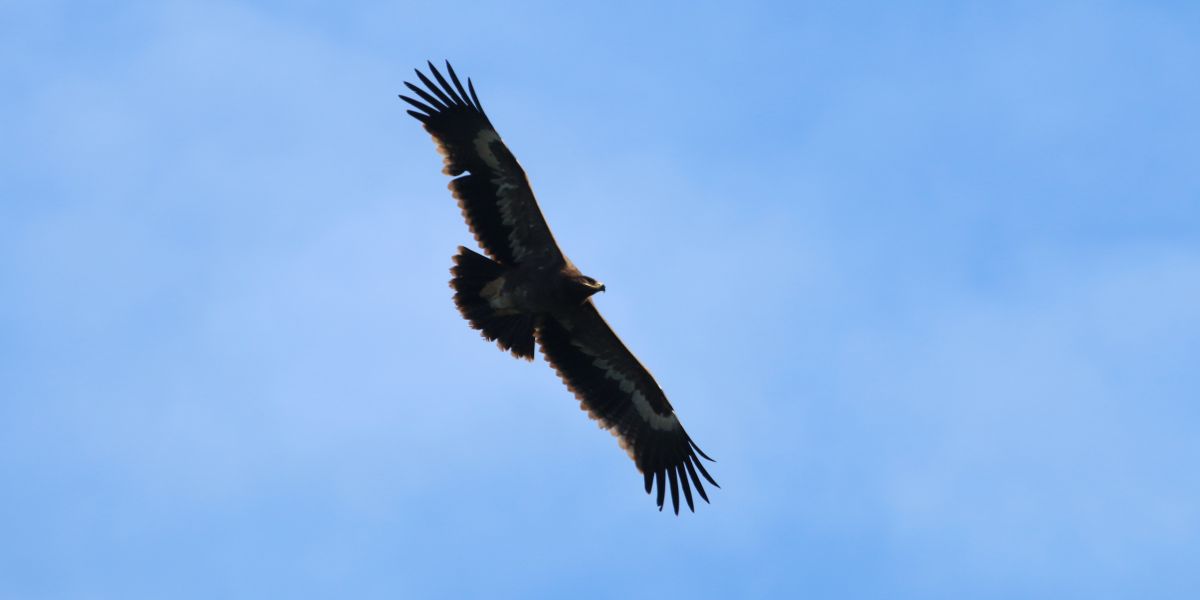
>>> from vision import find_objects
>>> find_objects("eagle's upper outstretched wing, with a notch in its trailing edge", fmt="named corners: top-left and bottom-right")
top-left (401, 62), bottom-right (563, 265)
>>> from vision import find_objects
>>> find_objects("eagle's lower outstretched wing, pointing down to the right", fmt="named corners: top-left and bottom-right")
top-left (536, 300), bottom-right (720, 515)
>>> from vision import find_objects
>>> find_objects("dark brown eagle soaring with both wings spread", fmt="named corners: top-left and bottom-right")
top-left (400, 61), bottom-right (720, 515)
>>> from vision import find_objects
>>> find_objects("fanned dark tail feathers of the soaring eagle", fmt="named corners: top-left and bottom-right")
top-left (450, 246), bottom-right (535, 360)
